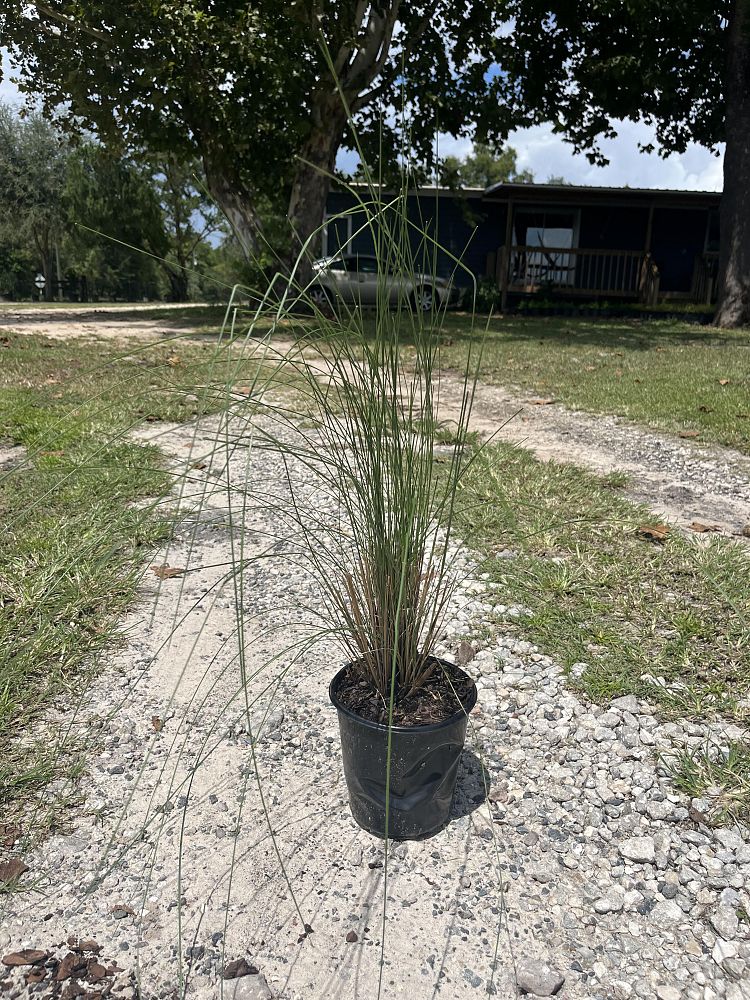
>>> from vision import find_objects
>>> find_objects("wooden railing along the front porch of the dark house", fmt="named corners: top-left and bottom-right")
top-left (488, 246), bottom-right (659, 304)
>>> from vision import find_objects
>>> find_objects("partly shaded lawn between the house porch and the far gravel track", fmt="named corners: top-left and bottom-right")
top-left (434, 313), bottom-right (750, 454)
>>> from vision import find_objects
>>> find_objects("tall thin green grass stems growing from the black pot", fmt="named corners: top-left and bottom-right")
top-left (244, 188), bottom-right (479, 703)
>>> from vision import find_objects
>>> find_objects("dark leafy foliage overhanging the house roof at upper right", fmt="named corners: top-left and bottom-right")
top-left (497, 0), bottom-right (732, 163)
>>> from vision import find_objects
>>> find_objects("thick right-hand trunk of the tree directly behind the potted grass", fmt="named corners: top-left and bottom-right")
top-left (287, 114), bottom-right (346, 284)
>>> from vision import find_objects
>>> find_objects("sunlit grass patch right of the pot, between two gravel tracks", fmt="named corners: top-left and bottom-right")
top-left (457, 445), bottom-right (750, 721)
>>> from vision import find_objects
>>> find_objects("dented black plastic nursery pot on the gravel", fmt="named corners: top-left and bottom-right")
top-left (329, 666), bottom-right (477, 840)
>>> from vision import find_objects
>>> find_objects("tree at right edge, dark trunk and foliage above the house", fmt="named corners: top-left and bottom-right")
top-left (496, 0), bottom-right (750, 326)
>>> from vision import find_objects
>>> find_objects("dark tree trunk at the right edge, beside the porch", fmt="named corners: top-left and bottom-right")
top-left (715, 0), bottom-right (750, 327)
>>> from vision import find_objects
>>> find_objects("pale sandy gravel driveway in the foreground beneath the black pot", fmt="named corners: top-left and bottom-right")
top-left (0, 410), bottom-right (750, 1000)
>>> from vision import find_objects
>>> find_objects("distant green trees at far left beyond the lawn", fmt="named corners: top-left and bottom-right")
top-left (0, 103), bottom-right (232, 301)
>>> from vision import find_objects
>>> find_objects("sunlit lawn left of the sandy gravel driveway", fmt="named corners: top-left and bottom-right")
top-left (0, 335), bottom-right (268, 836)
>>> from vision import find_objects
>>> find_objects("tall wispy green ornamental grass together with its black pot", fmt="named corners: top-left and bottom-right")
top-left (253, 180), bottom-right (478, 839)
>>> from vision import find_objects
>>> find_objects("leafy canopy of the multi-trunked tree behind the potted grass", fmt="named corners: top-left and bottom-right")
top-left (0, 0), bottom-right (506, 274)
